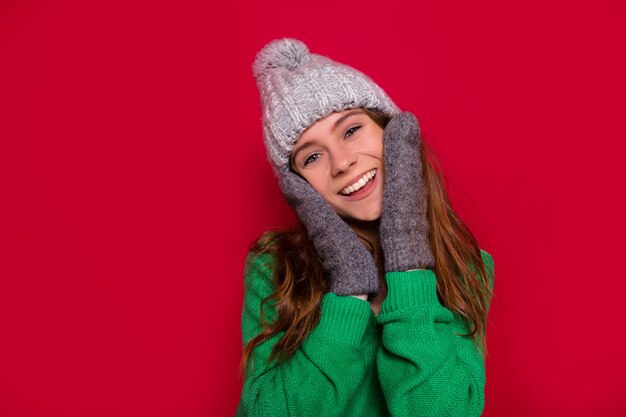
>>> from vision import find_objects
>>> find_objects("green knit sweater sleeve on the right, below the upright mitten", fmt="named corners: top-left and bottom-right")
top-left (376, 250), bottom-right (494, 417)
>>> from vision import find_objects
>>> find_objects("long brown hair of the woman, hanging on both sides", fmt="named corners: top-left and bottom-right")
top-left (240, 109), bottom-right (493, 375)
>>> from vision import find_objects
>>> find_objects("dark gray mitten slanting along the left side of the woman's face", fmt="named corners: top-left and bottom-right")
top-left (280, 171), bottom-right (379, 295)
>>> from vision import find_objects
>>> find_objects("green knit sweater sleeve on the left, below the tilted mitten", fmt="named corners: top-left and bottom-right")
top-left (237, 250), bottom-right (382, 417)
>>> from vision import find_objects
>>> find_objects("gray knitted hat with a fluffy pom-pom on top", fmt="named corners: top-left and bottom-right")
top-left (252, 38), bottom-right (400, 174)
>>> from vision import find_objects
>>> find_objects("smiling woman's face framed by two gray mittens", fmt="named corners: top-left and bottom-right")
top-left (291, 109), bottom-right (384, 221)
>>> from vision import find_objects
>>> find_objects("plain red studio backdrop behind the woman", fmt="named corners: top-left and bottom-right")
top-left (0, 0), bottom-right (626, 417)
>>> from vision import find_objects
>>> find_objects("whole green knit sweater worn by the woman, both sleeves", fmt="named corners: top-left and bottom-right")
top-left (237, 250), bottom-right (494, 417)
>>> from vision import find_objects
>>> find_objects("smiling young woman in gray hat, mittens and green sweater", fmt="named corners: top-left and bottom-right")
top-left (237, 38), bottom-right (494, 417)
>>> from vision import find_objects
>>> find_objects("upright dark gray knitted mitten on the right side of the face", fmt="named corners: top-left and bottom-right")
top-left (380, 112), bottom-right (435, 272)
